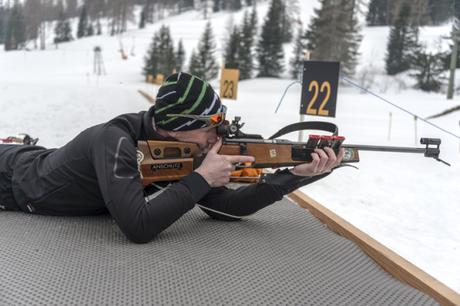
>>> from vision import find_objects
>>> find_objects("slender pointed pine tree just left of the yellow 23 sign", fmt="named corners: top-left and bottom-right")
top-left (190, 22), bottom-right (219, 80)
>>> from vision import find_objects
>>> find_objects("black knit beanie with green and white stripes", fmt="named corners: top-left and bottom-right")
top-left (149, 72), bottom-right (222, 131)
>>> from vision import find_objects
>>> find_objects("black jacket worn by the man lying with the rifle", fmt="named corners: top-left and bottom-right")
top-left (0, 112), bottom-right (328, 243)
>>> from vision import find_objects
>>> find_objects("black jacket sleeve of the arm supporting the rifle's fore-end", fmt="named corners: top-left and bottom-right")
top-left (199, 169), bottom-right (330, 221)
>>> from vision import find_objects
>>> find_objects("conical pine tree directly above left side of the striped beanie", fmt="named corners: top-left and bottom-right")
top-left (143, 25), bottom-right (176, 76)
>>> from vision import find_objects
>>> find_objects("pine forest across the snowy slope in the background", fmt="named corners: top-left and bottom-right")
top-left (0, 0), bottom-right (460, 91)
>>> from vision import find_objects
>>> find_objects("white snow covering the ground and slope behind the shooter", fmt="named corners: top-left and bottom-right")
top-left (0, 1), bottom-right (460, 292)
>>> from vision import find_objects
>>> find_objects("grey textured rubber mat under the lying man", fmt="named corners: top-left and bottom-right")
top-left (0, 200), bottom-right (436, 305)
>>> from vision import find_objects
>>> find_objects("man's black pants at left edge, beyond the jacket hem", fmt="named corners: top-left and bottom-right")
top-left (0, 144), bottom-right (20, 210)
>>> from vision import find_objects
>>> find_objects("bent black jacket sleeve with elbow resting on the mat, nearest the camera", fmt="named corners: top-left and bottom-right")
top-left (92, 127), bottom-right (210, 243)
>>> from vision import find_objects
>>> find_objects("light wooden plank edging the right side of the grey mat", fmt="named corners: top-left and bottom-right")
top-left (289, 190), bottom-right (460, 306)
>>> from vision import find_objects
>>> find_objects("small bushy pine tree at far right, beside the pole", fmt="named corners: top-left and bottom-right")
top-left (411, 49), bottom-right (444, 92)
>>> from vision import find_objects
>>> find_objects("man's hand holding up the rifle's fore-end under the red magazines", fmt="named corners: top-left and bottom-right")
top-left (291, 147), bottom-right (345, 176)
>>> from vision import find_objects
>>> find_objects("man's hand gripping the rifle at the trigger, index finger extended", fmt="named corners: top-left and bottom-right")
top-left (195, 139), bottom-right (254, 187)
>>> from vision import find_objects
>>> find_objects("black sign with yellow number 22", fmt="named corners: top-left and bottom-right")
top-left (300, 61), bottom-right (340, 117)
